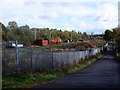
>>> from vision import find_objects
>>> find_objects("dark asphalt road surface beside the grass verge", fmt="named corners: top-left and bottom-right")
top-left (33, 52), bottom-right (120, 89)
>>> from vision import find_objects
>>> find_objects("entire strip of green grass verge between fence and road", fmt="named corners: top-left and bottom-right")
top-left (2, 53), bottom-right (103, 89)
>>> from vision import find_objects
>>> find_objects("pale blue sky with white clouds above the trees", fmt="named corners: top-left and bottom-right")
top-left (0, 0), bottom-right (119, 34)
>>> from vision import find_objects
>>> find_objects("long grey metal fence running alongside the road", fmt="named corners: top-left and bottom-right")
top-left (2, 47), bottom-right (103, 75)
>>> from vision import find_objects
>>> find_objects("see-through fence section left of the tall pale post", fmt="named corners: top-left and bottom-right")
top-left (2, 46), bottom-right (16, 74)
